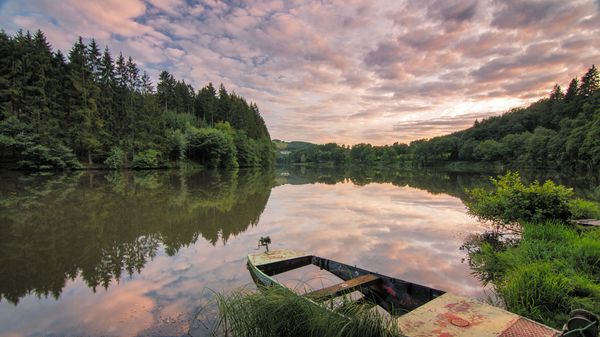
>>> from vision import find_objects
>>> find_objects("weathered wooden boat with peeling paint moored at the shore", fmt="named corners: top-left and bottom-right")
top-left (248, 249), bottom-right (560, 337)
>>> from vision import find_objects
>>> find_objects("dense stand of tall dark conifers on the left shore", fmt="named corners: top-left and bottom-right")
top-left (0, 30), bottom-right (273, 169)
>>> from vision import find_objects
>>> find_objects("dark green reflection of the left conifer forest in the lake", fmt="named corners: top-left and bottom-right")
top-left (0, 171), bottom-right (273, 304)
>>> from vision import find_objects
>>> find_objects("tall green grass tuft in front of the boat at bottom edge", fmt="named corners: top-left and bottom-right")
top-left (212, 287), bottom-right (401, 337)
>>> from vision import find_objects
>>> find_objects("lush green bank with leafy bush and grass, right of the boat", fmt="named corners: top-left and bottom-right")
top-left (465, 173), bottom-right (600, 328)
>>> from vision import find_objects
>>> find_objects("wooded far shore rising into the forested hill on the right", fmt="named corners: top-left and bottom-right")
top-left (275, 66), bottom-right (600, 172)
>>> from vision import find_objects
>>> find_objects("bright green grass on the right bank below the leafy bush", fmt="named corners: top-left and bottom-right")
top-left (469, 221), bottom-right (600, 328)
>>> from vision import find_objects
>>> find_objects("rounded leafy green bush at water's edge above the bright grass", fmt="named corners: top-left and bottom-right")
top-left (467, 171), bottom-right (573, 224)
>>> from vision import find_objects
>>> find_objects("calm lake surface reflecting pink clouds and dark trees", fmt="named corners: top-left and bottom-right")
top-left (0, 169), bottom-right (592, 336)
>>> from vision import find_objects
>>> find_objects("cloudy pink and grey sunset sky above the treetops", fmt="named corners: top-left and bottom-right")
top-left (0, 0), bottom-right (600, 145)
